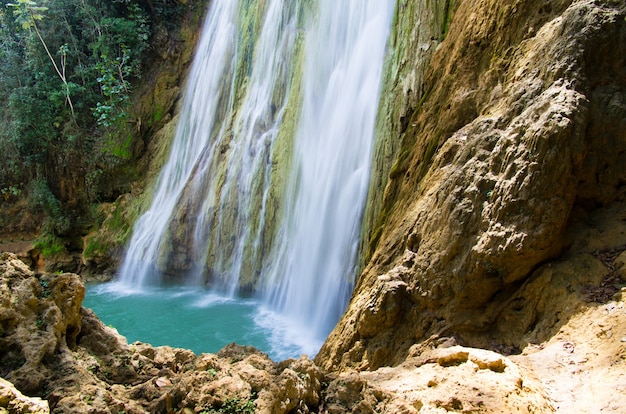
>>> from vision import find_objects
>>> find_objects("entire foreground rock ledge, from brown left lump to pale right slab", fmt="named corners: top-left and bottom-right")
top-left (0, 253), bottom-right (552, 413)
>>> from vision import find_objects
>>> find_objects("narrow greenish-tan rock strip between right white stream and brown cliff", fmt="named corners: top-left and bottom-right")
top-left (359, 0), bottom-right (453, 267)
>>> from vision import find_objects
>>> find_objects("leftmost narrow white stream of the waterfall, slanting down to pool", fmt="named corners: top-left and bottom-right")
top-left (120, 1), bottom-right (238, 288)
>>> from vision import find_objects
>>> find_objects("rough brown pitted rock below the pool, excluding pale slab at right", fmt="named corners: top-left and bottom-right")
top-left (0, 253), bottom-right (356, 413)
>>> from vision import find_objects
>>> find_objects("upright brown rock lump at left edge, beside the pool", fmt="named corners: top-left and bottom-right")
top-left (0, 253), bottom-right (85, 393)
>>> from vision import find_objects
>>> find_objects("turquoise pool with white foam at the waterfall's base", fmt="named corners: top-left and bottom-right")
top-left (83, 282), bottom-right (321, 361)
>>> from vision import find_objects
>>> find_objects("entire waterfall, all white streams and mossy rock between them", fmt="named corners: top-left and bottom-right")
top-left (119, 0), bottom-right (395, 352)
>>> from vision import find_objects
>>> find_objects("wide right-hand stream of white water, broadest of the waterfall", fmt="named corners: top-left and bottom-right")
top-left (266, 0), bottom-right (394, 350)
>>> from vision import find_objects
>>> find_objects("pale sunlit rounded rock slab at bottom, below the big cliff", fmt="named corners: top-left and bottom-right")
top-left (361, 346), bottom-right (553, 413)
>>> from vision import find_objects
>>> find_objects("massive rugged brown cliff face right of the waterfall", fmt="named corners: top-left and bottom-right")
top-left (316, 0), bottom-right (626, 378)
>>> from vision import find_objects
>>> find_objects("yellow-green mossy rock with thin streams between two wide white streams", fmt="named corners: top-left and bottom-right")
top-left (152, 3), bottom-right (303, 291)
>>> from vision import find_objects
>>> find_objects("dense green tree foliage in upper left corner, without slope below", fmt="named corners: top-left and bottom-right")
top-left (0, 0), bottom-right (151, 155)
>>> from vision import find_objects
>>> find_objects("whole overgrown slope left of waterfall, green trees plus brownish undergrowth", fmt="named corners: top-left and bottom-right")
top-left (0, 0), bottom-right (183, 252)
